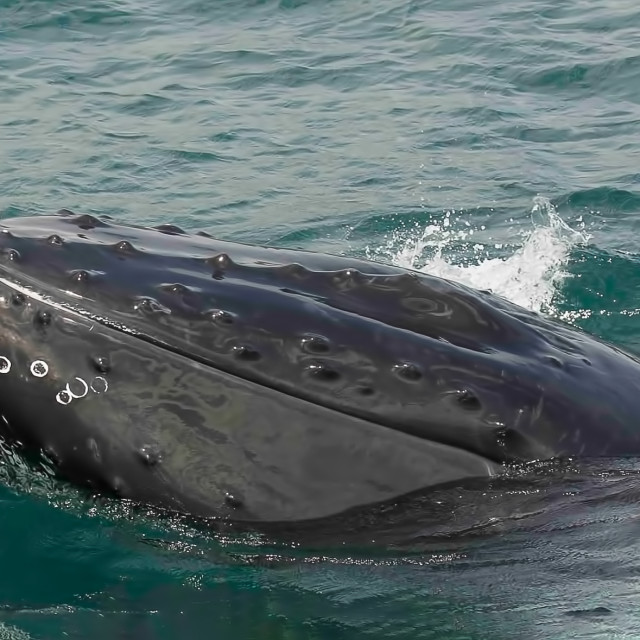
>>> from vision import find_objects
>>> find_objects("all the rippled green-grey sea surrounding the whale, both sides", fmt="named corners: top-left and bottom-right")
top-left (0, 0), bottom-right (640, 640)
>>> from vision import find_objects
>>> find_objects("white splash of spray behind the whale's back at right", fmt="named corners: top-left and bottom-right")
top-left (370, 197), bottom-right (588, 313)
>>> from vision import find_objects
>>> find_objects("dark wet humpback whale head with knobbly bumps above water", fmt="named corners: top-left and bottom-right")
top-left (0, 210), bottom-right (640, 521)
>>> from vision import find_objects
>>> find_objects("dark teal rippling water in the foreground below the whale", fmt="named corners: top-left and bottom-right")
top-left (0, 438), bottom-right (640, 640)
